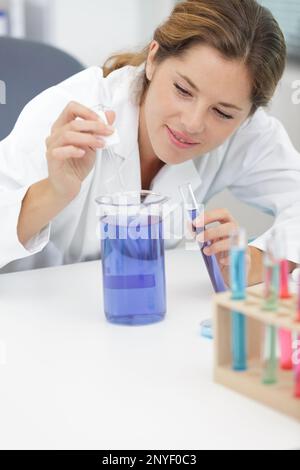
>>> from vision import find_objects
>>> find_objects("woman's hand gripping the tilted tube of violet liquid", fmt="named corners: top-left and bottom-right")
top-left (193, 209), bottom-right (251, 286)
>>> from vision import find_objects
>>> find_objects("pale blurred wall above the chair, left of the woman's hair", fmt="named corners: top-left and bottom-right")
top-left (47, 0), bottom-right (174, 66)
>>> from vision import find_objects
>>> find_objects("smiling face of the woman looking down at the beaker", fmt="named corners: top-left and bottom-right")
top-left (139, 41), bottom-right (252, 164)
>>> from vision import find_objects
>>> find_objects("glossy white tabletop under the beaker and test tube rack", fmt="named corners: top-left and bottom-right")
top-left (0, 250), bottom-right (300, 450)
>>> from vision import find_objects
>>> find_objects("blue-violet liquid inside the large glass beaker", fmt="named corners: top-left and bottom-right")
top-left (100, 216), bottom-right (166, 325)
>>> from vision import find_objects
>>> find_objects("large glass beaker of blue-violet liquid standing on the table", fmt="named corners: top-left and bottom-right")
top-left (96, 191), bottom-right (168, 325)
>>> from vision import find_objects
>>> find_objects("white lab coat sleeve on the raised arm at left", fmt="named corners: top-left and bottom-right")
top-left (0, 67), bottom-right (106, 268)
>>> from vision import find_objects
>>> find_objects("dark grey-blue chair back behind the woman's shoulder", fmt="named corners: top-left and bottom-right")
top-left (0, 37), bottom-right (84, 141)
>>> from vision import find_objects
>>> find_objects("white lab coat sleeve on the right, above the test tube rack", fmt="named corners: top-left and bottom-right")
top-left (228, 110), bottom-right (300, 263)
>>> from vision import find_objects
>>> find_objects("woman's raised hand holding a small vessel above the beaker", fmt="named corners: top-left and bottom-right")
top-left (46, 101), bottom-right (115, 201)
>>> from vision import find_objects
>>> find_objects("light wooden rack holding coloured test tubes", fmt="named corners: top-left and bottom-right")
top-left (214, 284), bottom-right (300, 421)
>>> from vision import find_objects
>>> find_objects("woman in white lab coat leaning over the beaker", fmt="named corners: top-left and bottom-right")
top-left (0, 0), bottom-right (300, 284)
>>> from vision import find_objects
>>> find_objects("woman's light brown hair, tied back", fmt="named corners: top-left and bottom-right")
top-left (103, 0), bottom-right (286, 114)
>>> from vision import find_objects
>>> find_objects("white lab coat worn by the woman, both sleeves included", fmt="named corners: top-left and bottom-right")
top-left (0, 66), bottom-right (300, 273)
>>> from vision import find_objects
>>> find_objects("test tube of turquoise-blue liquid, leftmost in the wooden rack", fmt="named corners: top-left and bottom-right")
top-left (230, 228), bottom-right (247, 371)
